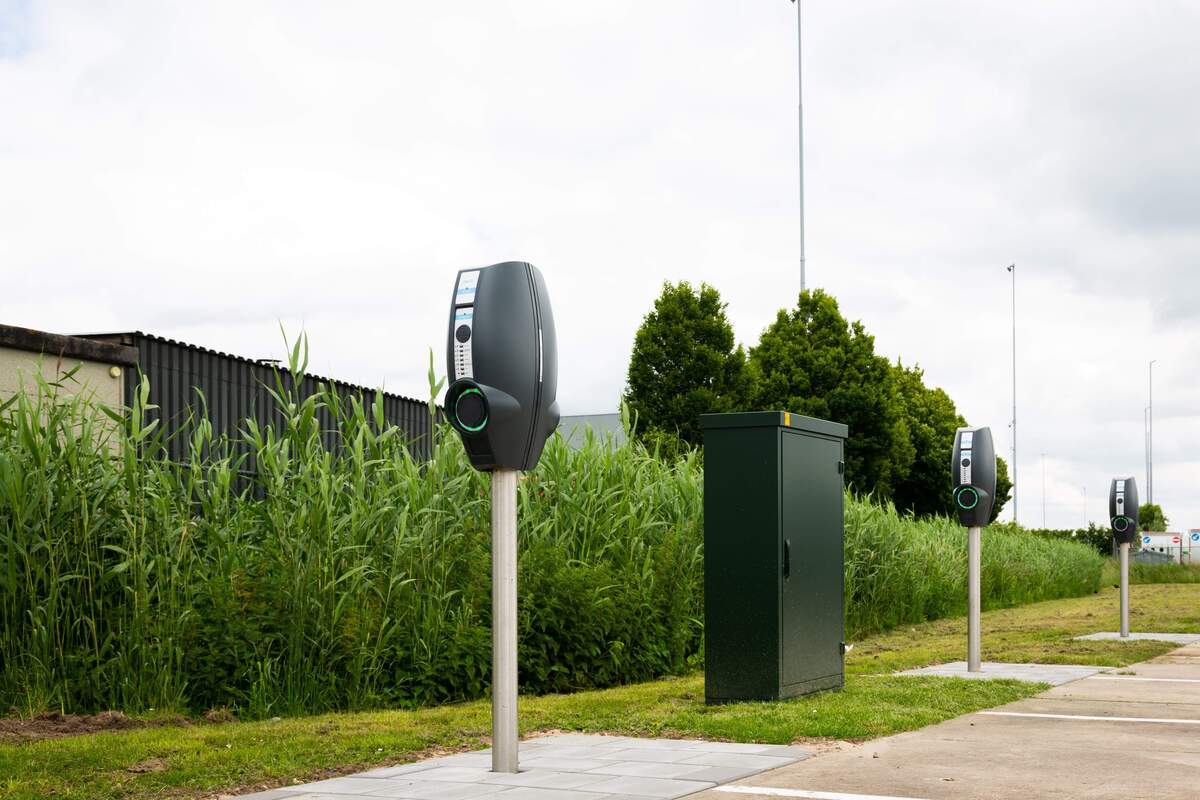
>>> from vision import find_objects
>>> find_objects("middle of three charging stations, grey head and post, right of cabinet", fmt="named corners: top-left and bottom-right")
top-left (950, 427), bottom-right (996, 672)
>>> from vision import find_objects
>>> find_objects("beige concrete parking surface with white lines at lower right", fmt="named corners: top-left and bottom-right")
top-left (695, 644), bottom-right (1200, 800)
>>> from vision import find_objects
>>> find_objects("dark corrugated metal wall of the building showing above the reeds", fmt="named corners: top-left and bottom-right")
top-left (81, 332), bottom-right (432, 469)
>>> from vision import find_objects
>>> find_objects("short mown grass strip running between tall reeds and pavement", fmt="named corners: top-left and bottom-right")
top-left (0, 584), bottom-right (1200, 800)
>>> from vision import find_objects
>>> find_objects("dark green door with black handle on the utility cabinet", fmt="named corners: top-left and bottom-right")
top-left (780, 431), bottom-right (845, 686)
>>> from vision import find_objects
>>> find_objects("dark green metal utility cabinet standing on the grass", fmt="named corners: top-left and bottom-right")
top-left (700, 411), bottom-right (846, 703)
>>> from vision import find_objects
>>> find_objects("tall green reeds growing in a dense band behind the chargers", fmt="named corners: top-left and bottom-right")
top-left (0, 347), bottom-right (1102, 717)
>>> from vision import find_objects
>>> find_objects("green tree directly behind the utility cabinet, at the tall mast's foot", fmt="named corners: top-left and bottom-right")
top-left (750, 289), bottom-right (907, 498)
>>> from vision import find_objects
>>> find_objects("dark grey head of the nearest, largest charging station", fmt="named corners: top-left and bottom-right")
top-left (444, 261), bottom-right (559, 471)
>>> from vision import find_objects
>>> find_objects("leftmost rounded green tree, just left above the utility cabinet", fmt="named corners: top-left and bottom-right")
top-left (624, 282), bottom-right (751, 445)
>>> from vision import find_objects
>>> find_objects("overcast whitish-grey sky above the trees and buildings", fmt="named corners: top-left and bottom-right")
top-left (0, 0), bottom-right (1200, 530)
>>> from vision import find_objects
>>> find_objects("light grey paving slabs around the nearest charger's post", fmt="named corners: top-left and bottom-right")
top-left (237, 735), bottom-right (812, 800)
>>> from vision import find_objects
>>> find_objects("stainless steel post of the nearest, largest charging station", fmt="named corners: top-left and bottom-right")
top-left (492, 469), bottom-right (517, 772)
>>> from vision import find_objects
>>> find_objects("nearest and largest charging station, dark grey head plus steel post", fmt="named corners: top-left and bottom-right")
top-left (444, 261), bottom-right (559, 772)
